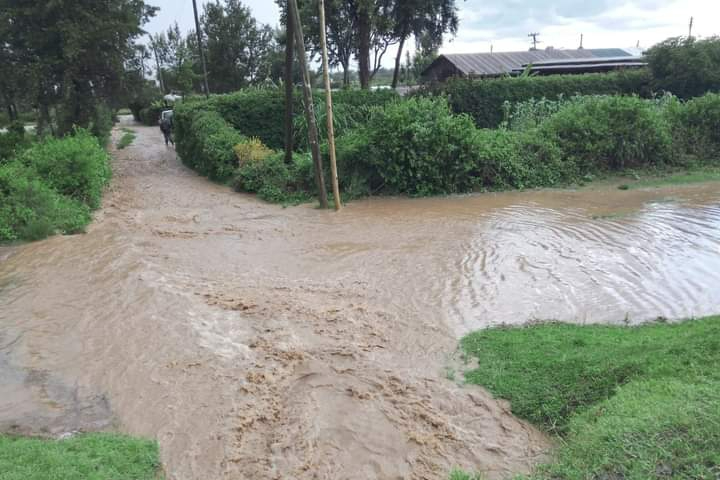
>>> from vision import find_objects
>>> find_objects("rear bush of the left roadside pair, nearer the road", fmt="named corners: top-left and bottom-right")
top-left (18, 130), bottom-right (110, 209)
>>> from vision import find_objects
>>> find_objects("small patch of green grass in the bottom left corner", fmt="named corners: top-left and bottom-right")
top-left (0, 433), bottom-right (161, 480)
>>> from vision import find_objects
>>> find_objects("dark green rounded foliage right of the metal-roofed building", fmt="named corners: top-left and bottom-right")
top-left (646, 37), bottom-right (720, 99)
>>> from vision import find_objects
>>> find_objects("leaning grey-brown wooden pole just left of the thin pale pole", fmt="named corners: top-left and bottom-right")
top-left (289, 0), bottom-right (328, 208)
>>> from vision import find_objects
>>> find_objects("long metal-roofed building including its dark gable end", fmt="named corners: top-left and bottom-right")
top-left (422, 48), bottom-right (634, 82)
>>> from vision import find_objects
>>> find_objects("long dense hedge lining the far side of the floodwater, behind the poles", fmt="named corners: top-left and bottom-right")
top-left (176, 89), bottom-right (720, 201)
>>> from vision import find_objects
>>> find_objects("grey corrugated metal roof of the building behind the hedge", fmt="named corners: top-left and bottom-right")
top-left (423, 48), bottom-right (631, 76)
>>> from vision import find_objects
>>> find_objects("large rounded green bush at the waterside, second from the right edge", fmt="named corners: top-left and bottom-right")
top-left (540, 96), bottom-right (671, 173)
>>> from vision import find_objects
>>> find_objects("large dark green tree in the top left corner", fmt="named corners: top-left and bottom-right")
top-left (0, 0), bottom-right (156, 134)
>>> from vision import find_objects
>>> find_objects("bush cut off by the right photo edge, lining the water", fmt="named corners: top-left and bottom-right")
top-left (668, 93), bottom-right (720, 162)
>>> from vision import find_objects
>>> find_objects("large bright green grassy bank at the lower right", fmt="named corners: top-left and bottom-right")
top-left (458, 316), bottom-right (720, 480)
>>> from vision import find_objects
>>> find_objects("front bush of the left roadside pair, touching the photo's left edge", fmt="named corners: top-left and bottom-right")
top-left (0, 161), bottom-right (90, 241)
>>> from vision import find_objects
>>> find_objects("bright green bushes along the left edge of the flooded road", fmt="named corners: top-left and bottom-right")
top-left (0, 130), bottom-right (110, 241)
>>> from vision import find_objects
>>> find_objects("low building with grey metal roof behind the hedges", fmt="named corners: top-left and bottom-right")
top-left (421, 48), bottom-right (642, 83)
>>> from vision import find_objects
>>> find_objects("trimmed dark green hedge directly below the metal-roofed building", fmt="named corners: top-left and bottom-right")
top-left (420, 70), bottom-right (651, 128)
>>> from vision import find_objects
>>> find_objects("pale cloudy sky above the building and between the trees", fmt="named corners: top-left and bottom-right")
top-left (146, 0), bottom-right (720, 66)
